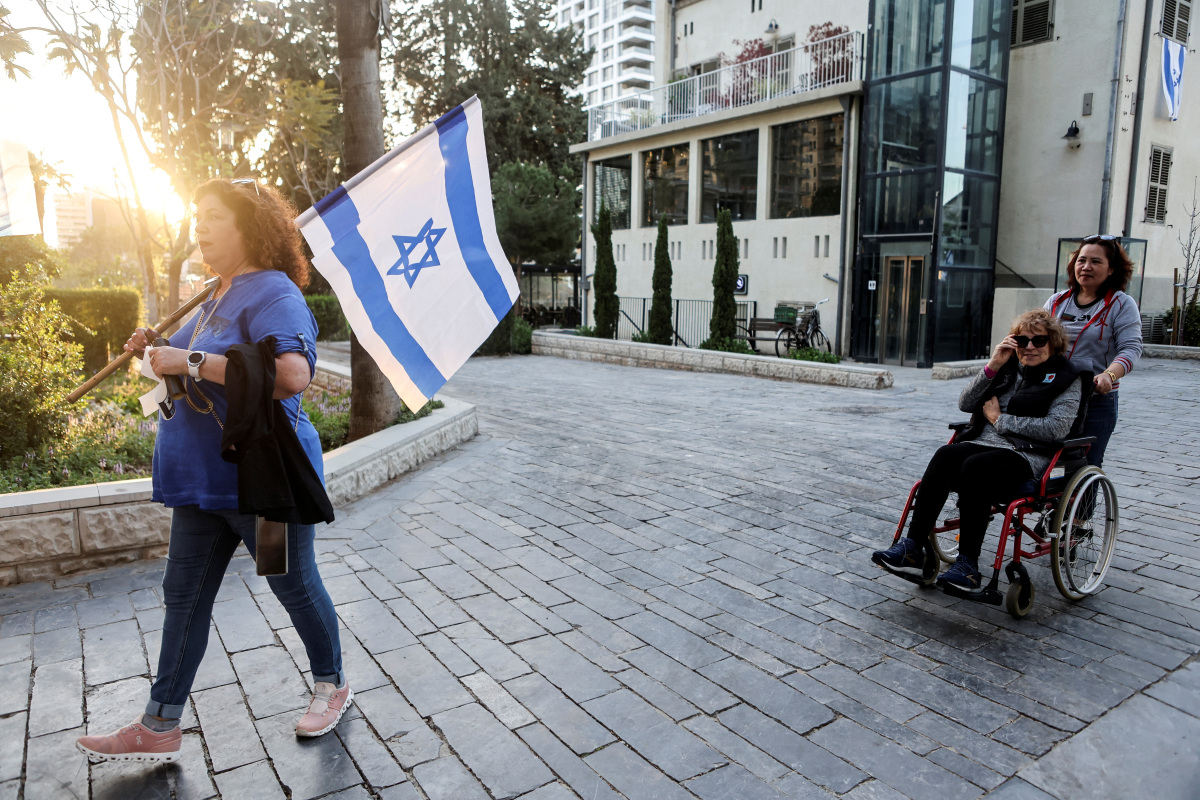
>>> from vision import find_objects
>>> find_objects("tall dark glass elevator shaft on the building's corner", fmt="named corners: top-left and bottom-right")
top-left (851, 0), bottom-right (1012, 366)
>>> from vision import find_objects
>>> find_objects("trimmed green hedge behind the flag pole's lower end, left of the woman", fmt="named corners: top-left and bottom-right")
top-left (44, 289), bottom-right (143, 374)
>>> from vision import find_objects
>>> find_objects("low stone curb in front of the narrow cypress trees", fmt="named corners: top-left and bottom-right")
top-left (533, 331), bottom-right (895, 390)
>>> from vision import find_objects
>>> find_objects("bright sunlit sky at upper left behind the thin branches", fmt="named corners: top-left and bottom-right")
top-left (0, 0), bottom-right (184, 244)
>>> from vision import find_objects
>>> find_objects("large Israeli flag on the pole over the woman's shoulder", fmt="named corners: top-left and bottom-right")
top-left (296, 97), bottom-right (517, 410)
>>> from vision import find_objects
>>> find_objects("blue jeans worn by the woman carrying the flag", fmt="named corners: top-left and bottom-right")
top-left (146, 506), bottom-right (343, 720)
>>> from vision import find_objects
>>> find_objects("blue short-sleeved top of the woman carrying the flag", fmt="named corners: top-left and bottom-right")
top-left (152, 270), bottom-right (325, 510)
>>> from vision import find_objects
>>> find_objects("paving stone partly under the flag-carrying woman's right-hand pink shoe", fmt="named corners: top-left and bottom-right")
top-left (254, 710), bottom-right (362, 800)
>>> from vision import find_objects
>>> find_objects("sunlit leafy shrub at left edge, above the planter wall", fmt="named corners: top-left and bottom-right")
top-left (0, 279), bottom-right (82, 465)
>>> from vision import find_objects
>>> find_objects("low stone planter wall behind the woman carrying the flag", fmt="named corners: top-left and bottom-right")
top-left (0, 398), bottom-right (479, 585)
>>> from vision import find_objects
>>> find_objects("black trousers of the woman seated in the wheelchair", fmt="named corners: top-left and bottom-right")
top-left (908, 441), bottom-right (1033, 566)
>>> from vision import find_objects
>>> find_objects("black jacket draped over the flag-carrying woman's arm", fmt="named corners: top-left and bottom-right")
top-left (221, 336), bottom-right (334, 524)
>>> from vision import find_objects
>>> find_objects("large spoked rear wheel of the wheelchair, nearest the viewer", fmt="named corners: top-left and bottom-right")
top-left (1050, 467), bottom-right (1117, 601)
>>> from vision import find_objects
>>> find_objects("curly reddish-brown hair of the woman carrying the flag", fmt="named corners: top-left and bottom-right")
top-left (192, 178), bottom-right (312, 289)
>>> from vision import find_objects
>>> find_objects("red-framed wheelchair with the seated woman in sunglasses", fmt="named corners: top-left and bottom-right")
top-left (892, 422), bottom-right (1118, 619)
